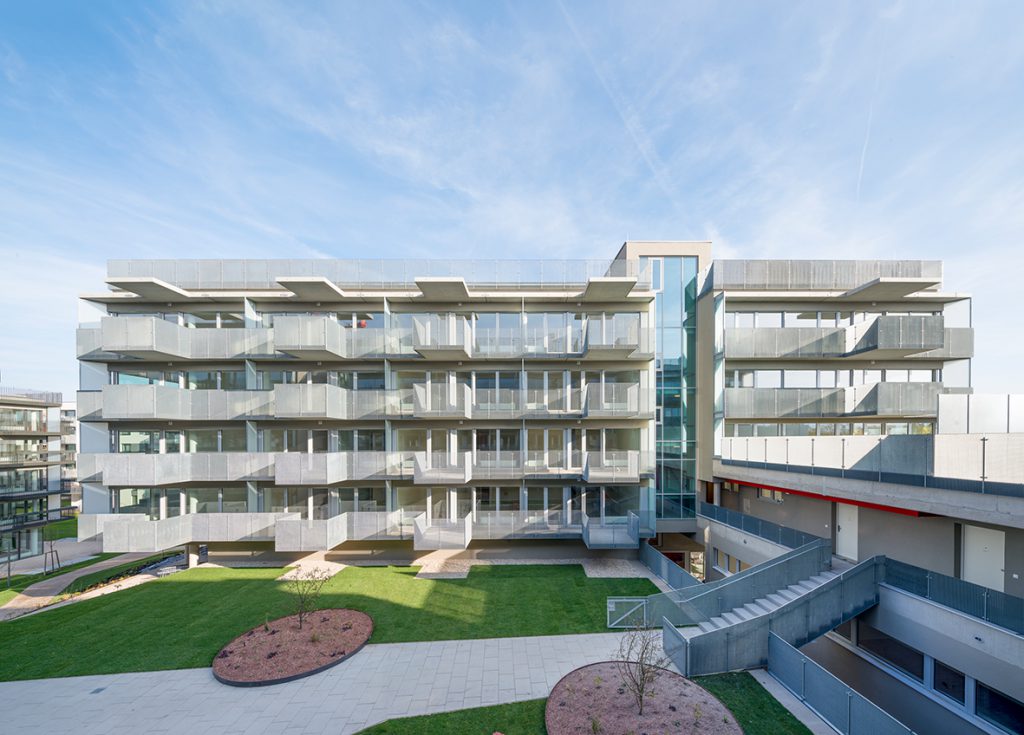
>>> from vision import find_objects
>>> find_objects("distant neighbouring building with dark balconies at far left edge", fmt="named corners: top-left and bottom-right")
top-left (0, 388), bottom-right (60, 560)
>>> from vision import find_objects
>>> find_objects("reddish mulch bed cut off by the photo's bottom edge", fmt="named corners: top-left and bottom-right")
top-left (544, 661), bottom-right (743, 735)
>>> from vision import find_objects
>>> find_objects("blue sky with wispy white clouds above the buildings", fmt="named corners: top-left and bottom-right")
top-left (0, 0), bottom-right (1024, 403)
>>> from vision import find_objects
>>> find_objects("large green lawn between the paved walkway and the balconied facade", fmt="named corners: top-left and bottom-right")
top-left (0, 565), bottom-right (657, 681)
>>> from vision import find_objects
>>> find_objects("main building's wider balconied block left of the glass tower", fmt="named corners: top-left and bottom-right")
top-left (78, 249), bottom-right (696, 550)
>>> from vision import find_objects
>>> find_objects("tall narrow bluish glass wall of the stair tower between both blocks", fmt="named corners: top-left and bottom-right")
top-left (641, 256), bottom-right (697, 518)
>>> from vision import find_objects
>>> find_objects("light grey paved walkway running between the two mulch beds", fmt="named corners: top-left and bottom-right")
top-left (0, 633), bottom-right (647, 735)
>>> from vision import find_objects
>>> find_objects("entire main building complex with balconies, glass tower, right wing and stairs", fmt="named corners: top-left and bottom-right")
top-left (78, 248), bottom-right (1024, 735)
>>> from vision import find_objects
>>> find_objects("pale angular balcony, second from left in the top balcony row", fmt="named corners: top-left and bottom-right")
top-left (273, 316), bottom-right (385, 360)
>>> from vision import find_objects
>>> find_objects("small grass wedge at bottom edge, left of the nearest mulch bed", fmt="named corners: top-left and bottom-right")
top-left (357, 699), bottom-right (548, 735)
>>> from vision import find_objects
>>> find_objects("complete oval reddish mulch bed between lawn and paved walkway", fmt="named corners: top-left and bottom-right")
top-left (213, 609), bottom-right (374, 687)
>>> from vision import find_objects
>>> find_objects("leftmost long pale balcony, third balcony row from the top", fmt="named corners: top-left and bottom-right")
top-left (78, 451), bottom-right (273, 487)
